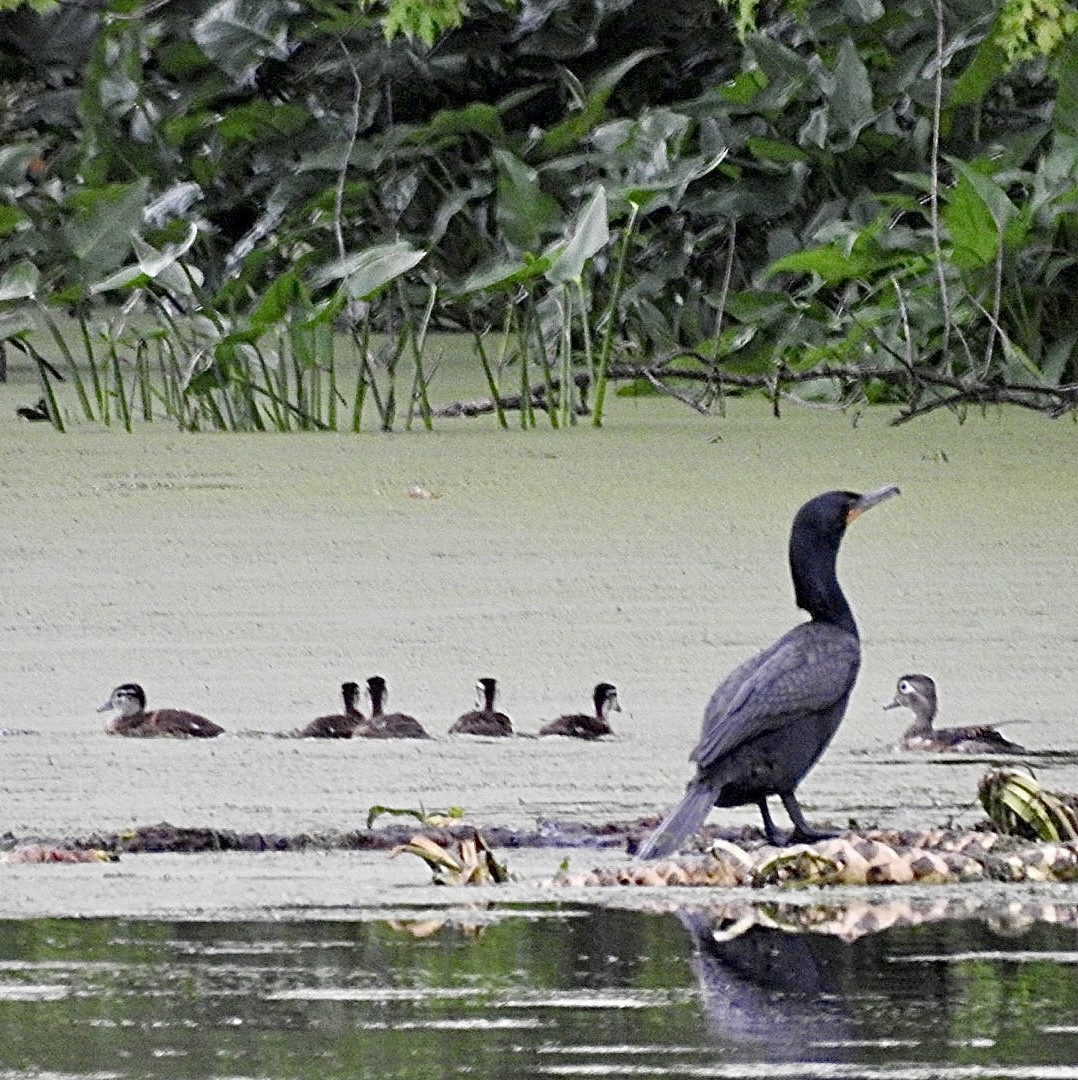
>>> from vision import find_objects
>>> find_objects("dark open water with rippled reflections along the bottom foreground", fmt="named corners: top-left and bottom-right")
top-left (0, 904), bottom-right (1078, 1080)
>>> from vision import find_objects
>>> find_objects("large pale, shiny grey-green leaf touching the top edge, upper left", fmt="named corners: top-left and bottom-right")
top-left (191, 0), bottom-right (288, 84)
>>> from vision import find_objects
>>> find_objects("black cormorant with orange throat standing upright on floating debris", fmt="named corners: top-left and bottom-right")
top-left (638, 485), bottom-right (899, 859)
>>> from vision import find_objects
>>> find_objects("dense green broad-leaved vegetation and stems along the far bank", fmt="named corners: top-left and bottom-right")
top-left (0, 0), bottom-right (1078, 429)
